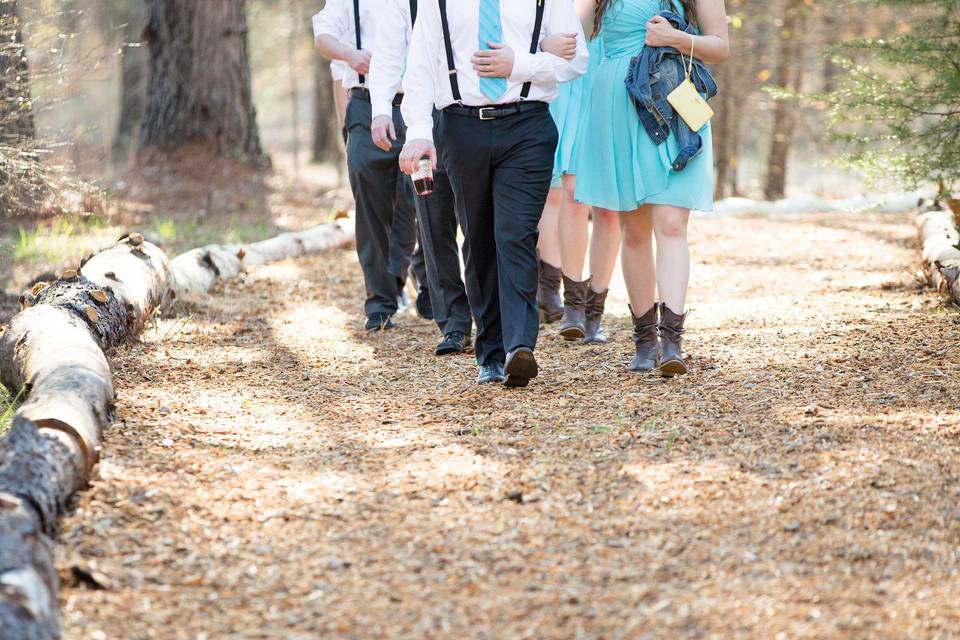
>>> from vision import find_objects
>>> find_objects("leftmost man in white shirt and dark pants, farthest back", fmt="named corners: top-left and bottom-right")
top-left (313, 0), bottom-right (426, 331)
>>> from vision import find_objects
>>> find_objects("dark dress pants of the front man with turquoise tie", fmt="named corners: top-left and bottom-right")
top-left (437, 104), bottom-right (558, 365)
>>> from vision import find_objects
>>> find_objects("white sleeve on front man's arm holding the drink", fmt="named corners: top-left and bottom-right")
top-left (401, 0), bottom-right (443, 141)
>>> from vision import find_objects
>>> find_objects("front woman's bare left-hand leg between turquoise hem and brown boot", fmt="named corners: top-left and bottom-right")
top-left (620, 207), bottom-right (657, 314)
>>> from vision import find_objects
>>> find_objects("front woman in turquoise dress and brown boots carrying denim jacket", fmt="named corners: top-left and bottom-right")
top-left (575, 0), bottom-right (729, 377)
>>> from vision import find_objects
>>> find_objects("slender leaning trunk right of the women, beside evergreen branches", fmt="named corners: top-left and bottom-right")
top-left (764, 0), bottom-right (804, 200)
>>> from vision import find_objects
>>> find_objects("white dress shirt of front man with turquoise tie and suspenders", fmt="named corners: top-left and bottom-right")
top-left (402, 0), bottom-right (589, 140)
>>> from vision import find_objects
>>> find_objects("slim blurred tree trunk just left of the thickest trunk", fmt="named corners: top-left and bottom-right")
top-left (112, 0), bottom-right (149, 165)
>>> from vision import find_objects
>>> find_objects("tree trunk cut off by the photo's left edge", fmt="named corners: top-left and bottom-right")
top-left (0, 0), bottom-right (34, 148)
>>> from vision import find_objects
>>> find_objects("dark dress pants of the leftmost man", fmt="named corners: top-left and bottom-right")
top-left (346, 97), bottom-right (417, 316)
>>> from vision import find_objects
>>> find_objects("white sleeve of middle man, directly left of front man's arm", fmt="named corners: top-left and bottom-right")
top-left (367, 0), bottom-right (409, 118)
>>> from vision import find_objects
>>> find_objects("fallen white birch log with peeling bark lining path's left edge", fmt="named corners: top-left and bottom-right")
top-left (0, 221), bottom-right (353, 640)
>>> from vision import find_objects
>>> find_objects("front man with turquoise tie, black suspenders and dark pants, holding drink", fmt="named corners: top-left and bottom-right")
top-left (400, 0), bottom-right (588, 387)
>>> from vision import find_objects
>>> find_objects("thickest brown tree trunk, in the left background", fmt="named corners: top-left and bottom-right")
top-left (140, 0), bottom-right (266, 163)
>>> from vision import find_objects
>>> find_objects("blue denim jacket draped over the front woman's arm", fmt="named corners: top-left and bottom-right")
top-left (625, 11), bottom-right (717, 171)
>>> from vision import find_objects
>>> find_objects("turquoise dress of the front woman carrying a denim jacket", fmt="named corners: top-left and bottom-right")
top-left (574, 0), bottom-right (713, 211)
